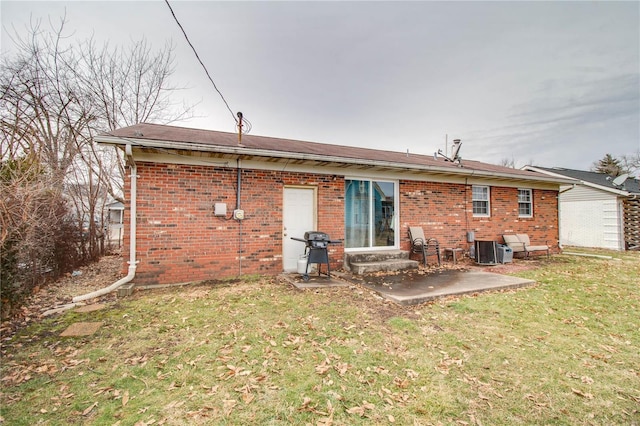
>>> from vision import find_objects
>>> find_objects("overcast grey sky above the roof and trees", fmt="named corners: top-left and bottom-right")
top-left (0, 0), bottom-right (640, 170)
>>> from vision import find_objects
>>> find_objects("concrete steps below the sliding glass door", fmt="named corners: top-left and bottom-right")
top-left (344, 250), bottom-right (419, 275)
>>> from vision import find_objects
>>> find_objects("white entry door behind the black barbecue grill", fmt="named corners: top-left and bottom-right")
top-left (282, 187), bottom-right (316, 272)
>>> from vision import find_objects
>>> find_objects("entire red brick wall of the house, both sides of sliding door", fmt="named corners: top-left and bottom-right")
top-left (123, 163), bottom-right (558, 285)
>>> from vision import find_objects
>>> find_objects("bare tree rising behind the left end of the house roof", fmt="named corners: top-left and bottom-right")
top-left (76, 39), bottom-right (193, 201)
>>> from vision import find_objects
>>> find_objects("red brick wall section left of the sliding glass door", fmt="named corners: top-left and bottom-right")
top-left (124, 163), bottom-right (344, 285)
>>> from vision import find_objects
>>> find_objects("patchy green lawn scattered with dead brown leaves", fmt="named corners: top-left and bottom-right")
top-left (0, 252), bottom-right (640, 425)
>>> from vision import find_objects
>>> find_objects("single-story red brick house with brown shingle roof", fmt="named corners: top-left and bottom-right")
top-left (96, 124), bottom-right (566, 285)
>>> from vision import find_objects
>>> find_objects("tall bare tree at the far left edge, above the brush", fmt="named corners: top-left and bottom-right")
top-left (0, 18), bottom-right (88, 190)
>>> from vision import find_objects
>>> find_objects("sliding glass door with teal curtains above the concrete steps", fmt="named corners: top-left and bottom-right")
top-left (345, 179), bottom-right (396, 249)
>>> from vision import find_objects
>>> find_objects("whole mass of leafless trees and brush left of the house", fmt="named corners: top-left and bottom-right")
top-left (0, 18), bottom-right (193, 316)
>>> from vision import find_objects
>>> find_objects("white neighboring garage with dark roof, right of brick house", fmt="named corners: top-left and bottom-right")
top-left (525, 166), bottom-right (640, 250)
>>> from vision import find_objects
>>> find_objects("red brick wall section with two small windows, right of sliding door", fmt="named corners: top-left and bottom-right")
top-left (400, 180), bottom-right (559, 250)
